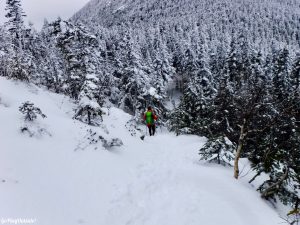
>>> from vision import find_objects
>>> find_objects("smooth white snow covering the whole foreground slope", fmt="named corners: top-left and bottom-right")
top-left (0, 78), bottom-right (281, 225)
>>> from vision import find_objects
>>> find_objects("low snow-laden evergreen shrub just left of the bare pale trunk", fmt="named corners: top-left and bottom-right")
top-left (199, 137), bottom-right (235, 166)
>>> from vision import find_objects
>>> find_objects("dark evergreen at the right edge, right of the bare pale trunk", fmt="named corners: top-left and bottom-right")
top-left (250, 99), bottom-right (300, 206)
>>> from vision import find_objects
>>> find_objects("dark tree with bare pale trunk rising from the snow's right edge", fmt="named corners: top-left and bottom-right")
top-left (204, 48), bottom-right (272, 178)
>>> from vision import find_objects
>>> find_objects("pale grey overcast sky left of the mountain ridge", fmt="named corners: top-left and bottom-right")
top-left (0, 0), bottom-right (89, 29)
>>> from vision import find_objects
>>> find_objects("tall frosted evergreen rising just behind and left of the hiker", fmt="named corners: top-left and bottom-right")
top-left (114, 28), bottom-right (151, 119)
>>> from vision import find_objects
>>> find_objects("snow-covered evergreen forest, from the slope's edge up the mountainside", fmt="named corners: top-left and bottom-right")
top-left (0, 0), bottom-right (300, 219)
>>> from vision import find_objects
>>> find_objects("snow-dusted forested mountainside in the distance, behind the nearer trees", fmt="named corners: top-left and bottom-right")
top-left (72, 0), bottom-right (300, 51)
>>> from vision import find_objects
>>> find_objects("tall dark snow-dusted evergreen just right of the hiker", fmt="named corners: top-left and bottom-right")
top-left (171, 43), bottom-right (215, 135)
